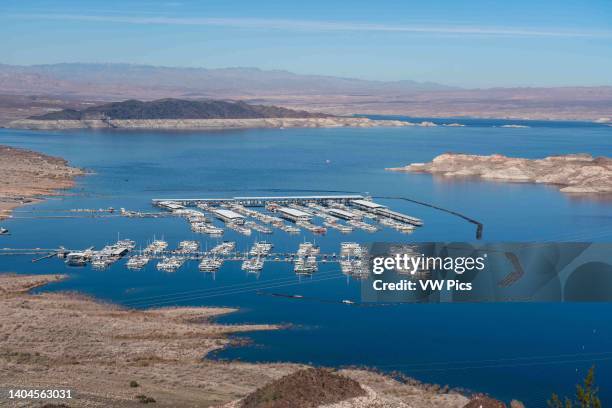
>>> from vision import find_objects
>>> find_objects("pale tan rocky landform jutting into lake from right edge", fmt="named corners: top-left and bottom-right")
top-left (387, 153), bottom-right (612, 194)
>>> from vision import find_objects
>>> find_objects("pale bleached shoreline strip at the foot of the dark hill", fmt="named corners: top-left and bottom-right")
top-left (8, 117), bottom-right (435, 130)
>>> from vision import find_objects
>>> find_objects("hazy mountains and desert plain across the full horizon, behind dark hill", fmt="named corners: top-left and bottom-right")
top-left (0, 63), bottom-right (612, 123)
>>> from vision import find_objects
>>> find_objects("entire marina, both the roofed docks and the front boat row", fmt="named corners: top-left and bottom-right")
top-left (0, 195), bottom-right (423, 275)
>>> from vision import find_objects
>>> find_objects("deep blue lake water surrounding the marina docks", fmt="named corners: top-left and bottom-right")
top-left (0, 120), bottom-right (612, 407)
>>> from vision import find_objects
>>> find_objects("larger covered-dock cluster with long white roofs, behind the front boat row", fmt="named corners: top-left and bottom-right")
top-left (152, 195), bottom-right (423, 236)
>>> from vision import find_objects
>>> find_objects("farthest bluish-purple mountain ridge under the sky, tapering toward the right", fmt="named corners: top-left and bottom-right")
top-left (0, 63), bottom-right (454, 98)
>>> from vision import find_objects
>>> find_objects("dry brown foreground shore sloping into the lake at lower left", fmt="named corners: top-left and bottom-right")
top-left (0, 274), bottom-right (469, 408)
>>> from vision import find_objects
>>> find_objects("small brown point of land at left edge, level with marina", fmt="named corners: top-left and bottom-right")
top-left (0, 145), bottom-right (85, 219)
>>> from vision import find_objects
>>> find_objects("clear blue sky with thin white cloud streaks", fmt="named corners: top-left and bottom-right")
top-left (0, 0), bottom-right (612, 88)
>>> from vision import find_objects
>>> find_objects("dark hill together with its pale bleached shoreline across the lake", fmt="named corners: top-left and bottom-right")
top-left (9, 99), bottom-right (416, 130)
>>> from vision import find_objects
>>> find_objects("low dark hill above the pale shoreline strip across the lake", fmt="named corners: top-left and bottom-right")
top-left (30, 99), bottom-right (328, 120)
